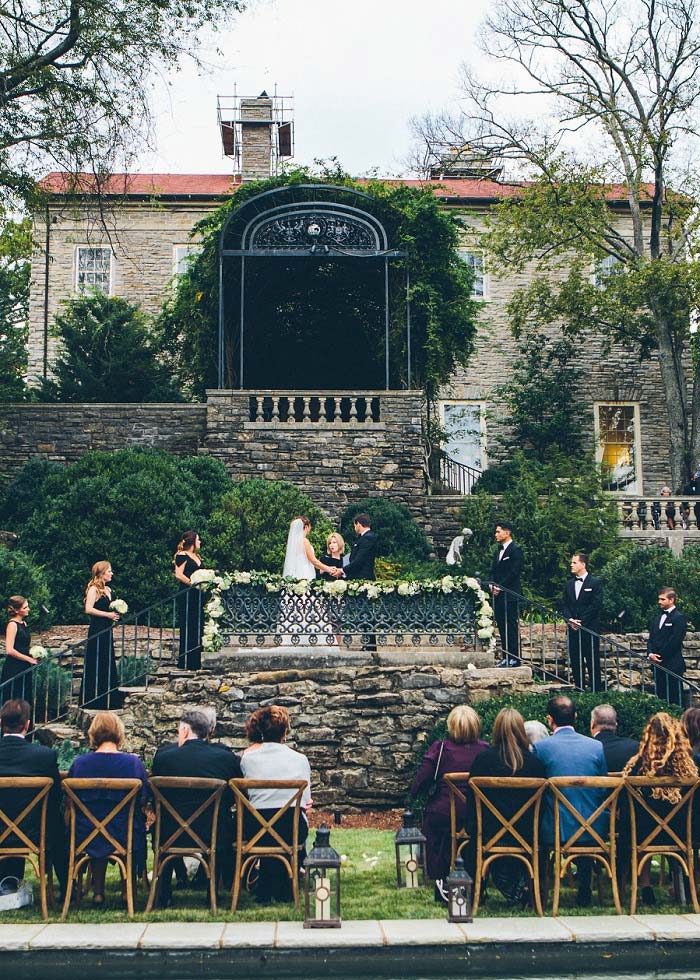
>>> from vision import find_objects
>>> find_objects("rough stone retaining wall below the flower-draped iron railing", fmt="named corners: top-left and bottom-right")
top-left (124, 665), bottom-right (536, 808)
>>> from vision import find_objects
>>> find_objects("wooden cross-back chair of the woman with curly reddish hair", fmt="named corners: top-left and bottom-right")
top-left (625, 776), bottom-right (700, 915)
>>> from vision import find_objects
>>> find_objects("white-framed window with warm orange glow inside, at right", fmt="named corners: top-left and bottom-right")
top-left (593, 402), bottom-right (642, 493)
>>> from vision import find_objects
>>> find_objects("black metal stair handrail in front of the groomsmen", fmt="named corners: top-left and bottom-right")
top-left (492, 586), bottom-right (700, 705)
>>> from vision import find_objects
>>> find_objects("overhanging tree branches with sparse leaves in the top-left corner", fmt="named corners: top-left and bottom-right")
top-left (0, 0), bottom-right (243, 201)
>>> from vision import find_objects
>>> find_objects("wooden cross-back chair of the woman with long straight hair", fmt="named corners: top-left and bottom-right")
top-left (469, 776), bottom-right (547, 915)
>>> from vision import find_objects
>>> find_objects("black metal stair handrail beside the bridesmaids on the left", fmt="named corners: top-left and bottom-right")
top-left (0, 589), bottom-right (201, 727)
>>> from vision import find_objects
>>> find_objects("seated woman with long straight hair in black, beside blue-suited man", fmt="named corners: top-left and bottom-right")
top-left (467, 708), bottom-right (544, 905)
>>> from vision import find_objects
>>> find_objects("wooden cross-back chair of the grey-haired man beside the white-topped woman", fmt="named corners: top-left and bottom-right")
top-left (146, 776), bottom-right (227, 915)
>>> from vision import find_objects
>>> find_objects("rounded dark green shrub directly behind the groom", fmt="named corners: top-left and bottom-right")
top-left (340, 497), bottom-right (431, 569)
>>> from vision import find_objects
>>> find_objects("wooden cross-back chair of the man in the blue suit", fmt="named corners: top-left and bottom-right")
top-left (549, 776), bottom-right (624, 915)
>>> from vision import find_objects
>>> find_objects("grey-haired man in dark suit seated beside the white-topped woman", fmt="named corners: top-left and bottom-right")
top-left (151, 708), bottom-right (243, 908)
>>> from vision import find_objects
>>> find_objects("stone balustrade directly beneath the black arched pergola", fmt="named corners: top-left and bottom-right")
top-left (249, 391), bottom-right (382, 425)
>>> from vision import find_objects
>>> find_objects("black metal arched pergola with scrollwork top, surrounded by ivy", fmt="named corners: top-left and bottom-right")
top-left (218, 184), bottom-right (411, 389)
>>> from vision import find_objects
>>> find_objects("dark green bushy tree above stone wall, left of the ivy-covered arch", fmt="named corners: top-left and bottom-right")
top-left (41, 293), bottom-right (180, 402)
